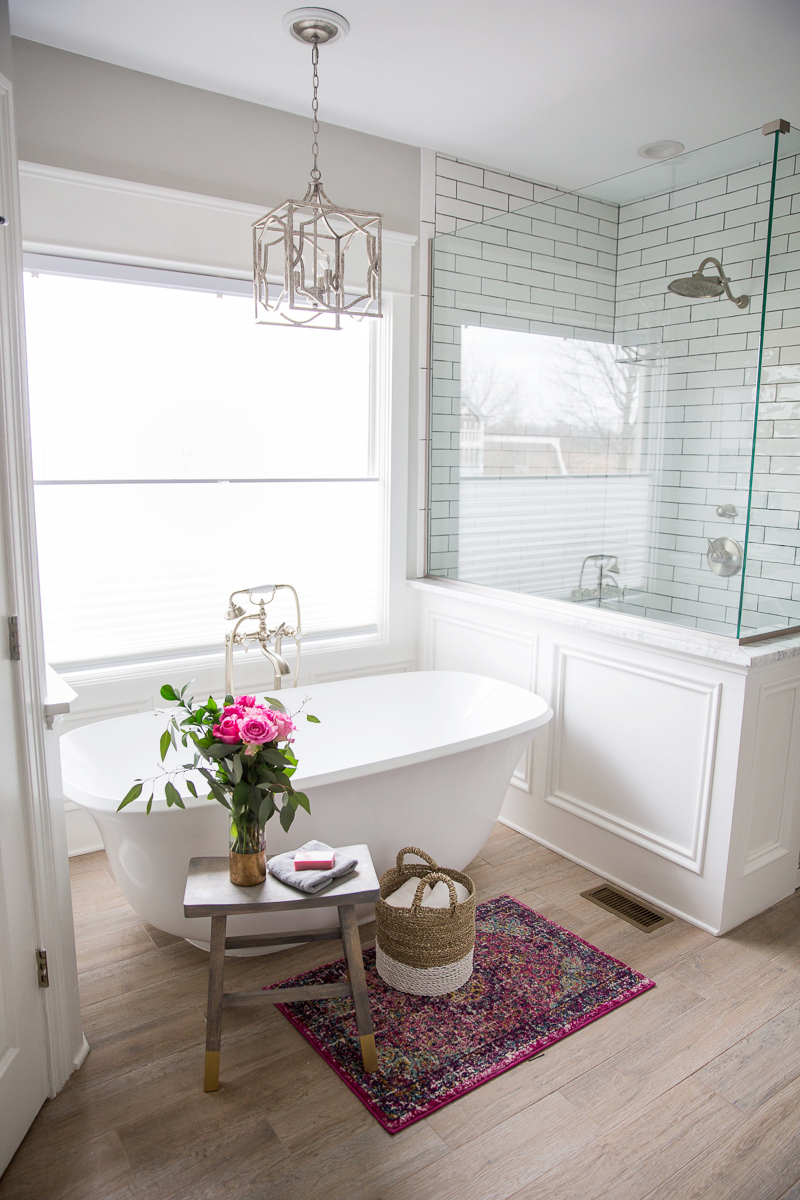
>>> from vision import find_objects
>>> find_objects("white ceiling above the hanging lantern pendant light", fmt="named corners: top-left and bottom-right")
top-left (10, 0), bottom-right (800, 187)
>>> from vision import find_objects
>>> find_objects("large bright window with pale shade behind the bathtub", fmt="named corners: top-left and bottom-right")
top-left (25, 256), bottom-right (383, 666)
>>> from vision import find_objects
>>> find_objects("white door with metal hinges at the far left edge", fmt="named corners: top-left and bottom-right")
top-left (0, 76), bottom-right (54, 1171)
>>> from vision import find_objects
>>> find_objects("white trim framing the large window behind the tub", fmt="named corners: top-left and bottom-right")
top-left (19, 161), bottom-right (419, 715)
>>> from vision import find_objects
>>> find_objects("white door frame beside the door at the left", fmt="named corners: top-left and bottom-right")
top-left (0, 74), bottom-right (83, 1096)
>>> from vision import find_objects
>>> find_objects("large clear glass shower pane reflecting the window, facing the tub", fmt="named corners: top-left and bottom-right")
top-left (429, 131), bottom-right (800, 636)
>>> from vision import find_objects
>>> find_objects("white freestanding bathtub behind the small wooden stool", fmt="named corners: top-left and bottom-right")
top-left (61, 671), bottom-right (553, 949)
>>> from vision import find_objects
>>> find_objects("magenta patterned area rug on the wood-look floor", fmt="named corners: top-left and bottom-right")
top-left (266, 895), bottom-right (655, 1133)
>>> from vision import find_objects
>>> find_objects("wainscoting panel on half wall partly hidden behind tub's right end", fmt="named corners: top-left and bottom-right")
top-left (428, 613), bottom-right (537, 792)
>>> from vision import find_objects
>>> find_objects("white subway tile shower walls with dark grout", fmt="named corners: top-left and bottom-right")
top-left (428, 146), bottom-right (800, 636)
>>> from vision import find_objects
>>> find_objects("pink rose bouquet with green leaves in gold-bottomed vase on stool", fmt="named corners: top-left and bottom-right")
top-left (118, 684), bottom-right (319, 887)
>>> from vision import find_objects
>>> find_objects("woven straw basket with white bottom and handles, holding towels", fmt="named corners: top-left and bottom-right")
top-left (375, 846), bottom-right (475, 996)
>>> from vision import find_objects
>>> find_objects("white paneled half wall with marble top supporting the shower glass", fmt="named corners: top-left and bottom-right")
top-left (417, 580), bottom-right (800, 934)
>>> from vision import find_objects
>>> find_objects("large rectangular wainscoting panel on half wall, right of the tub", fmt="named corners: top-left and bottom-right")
top-left (546, 644), bottom-right (722, 875)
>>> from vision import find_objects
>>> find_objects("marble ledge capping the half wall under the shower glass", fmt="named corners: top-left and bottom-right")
top-left (408, 577), bottom-right (800, 668)
